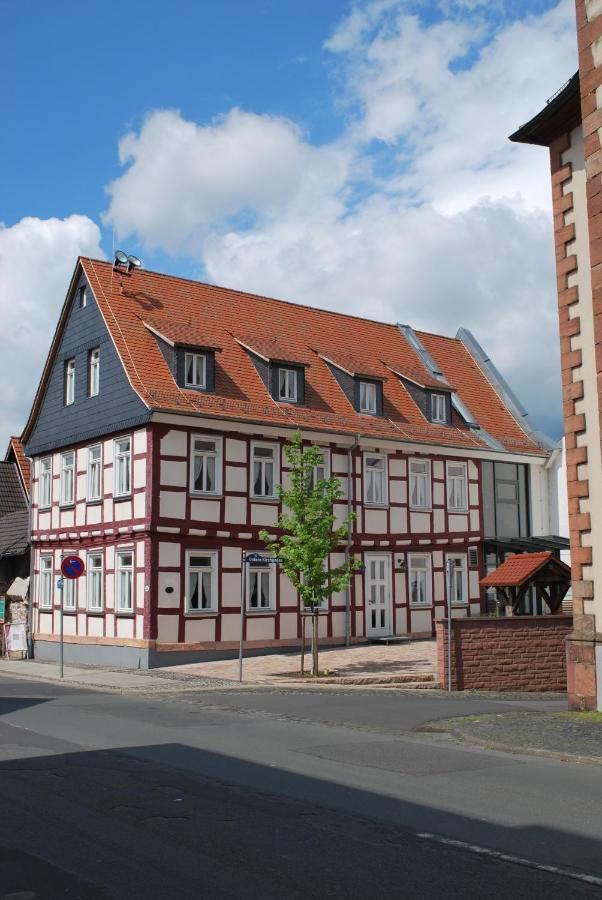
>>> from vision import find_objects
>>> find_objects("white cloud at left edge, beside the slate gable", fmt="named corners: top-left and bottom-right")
top-left (0, 215), bottom-right (104, 458)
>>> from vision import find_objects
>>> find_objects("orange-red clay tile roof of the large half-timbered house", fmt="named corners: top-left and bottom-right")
top-left (65, 258), bottom-right (545, 455)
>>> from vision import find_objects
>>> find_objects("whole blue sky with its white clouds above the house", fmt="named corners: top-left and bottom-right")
top-left (0, 0), bottom-right (576, 450)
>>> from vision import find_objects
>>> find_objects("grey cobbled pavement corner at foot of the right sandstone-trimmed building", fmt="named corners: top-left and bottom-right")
top-left (418, 710), bottom-right (602, 765)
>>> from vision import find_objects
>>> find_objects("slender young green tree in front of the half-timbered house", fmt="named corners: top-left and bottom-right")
top-left (260, 431), bottom-right (361, 676)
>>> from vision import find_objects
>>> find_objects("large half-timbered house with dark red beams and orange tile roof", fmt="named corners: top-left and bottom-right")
top-left (22, 258), bottom-right (566, 666)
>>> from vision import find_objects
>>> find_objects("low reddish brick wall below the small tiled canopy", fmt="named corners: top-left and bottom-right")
top-left (435, 616), bottom-right (573, 691)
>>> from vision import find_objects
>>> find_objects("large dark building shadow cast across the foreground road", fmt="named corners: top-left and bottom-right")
top-left (0, 736), bottom-right (602, 900)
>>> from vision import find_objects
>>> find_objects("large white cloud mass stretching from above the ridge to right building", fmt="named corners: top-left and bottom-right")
top-left (107, 0), bottom-right (576, 430)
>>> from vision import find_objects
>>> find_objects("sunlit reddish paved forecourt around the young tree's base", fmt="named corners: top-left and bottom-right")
top-left (165, 640), bottom-right (437, 687)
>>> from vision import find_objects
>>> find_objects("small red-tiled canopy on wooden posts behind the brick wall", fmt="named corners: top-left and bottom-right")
top-left (480, 550), bottom-right (571, 615)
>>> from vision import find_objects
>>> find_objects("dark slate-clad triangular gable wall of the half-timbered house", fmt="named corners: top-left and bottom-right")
top-left (25, 275), bottom-right (150, 456)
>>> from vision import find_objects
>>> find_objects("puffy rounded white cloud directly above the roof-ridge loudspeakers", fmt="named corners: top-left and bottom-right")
top-left (105, 109), bottom-right (346, 252)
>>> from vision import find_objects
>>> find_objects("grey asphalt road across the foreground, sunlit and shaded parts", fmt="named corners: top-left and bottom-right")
top-left (0, 678), bottom-right (602, 900)
